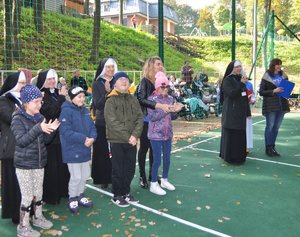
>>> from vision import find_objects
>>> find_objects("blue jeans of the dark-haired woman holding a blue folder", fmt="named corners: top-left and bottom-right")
top-left (265, 111), bottom-right (284, 146)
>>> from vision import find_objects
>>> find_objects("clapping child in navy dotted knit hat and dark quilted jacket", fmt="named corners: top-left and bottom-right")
top-left (11, 85), bottom-right (60, 236)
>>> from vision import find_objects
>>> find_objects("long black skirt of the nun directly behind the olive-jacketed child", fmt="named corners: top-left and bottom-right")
top-left (92, 125), bottom-right (112, 184)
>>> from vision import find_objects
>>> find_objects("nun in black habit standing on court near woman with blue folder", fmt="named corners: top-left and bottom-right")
top-left (220, 60), bottom-right (250, 164)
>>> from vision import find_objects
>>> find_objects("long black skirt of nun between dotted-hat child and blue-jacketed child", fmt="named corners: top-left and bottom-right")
top-left (43, 144), bottom-right (70, 204)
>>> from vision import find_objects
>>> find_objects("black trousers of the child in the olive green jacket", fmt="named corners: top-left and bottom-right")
top-left (110, 143), bottom-right (136, 197)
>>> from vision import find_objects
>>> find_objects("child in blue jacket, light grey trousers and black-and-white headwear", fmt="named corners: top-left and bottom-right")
top-left (59, 86), bottom-right (97, 213)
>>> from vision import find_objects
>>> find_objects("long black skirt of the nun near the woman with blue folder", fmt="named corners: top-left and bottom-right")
top-left (220, 128), bottom-right (247, 164)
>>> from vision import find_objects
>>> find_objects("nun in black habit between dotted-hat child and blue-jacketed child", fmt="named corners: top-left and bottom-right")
top-left (36, 69), bottom-right (70, 204)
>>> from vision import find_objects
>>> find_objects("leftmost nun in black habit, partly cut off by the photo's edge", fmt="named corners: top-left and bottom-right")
top-left (0, 71), bottom-right (26, 224)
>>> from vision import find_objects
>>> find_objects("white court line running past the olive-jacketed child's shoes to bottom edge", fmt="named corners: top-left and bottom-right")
top-left (85, 184), bottom-right (231, 237)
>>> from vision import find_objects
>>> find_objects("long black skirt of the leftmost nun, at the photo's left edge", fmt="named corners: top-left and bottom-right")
top-left (1, 159), bottom-right (21, 223)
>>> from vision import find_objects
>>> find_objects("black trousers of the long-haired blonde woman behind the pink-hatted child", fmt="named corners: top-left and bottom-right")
top-left (138, 122), bottom-right (153, 180)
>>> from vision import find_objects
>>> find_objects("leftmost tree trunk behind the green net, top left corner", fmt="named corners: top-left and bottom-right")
top-left (3, 0), bottom-right (13, 70)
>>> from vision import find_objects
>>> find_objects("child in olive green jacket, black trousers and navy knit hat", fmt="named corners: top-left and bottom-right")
top-left (104, 72), bottom-right (143, 207)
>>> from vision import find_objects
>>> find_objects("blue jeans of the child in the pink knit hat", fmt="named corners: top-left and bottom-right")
top-left (150, 139), bottom-right (172, 182)
